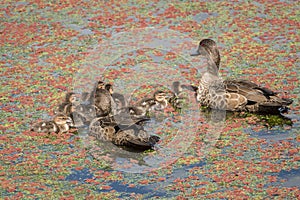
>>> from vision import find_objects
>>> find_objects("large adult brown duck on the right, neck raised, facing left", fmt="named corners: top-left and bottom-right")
top-left (191, 39), bottom-right (293, 114)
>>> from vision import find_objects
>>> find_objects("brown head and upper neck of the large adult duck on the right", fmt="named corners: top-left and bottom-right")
top-left (191, 39), bottom-right (221, 70)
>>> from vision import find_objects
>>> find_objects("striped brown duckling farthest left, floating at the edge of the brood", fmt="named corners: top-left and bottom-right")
top-left (31, 113), bottom-right (73, 133)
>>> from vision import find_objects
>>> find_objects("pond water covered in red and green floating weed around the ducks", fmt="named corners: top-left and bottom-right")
top-left (0, 1), bottom-right (300, 199)
